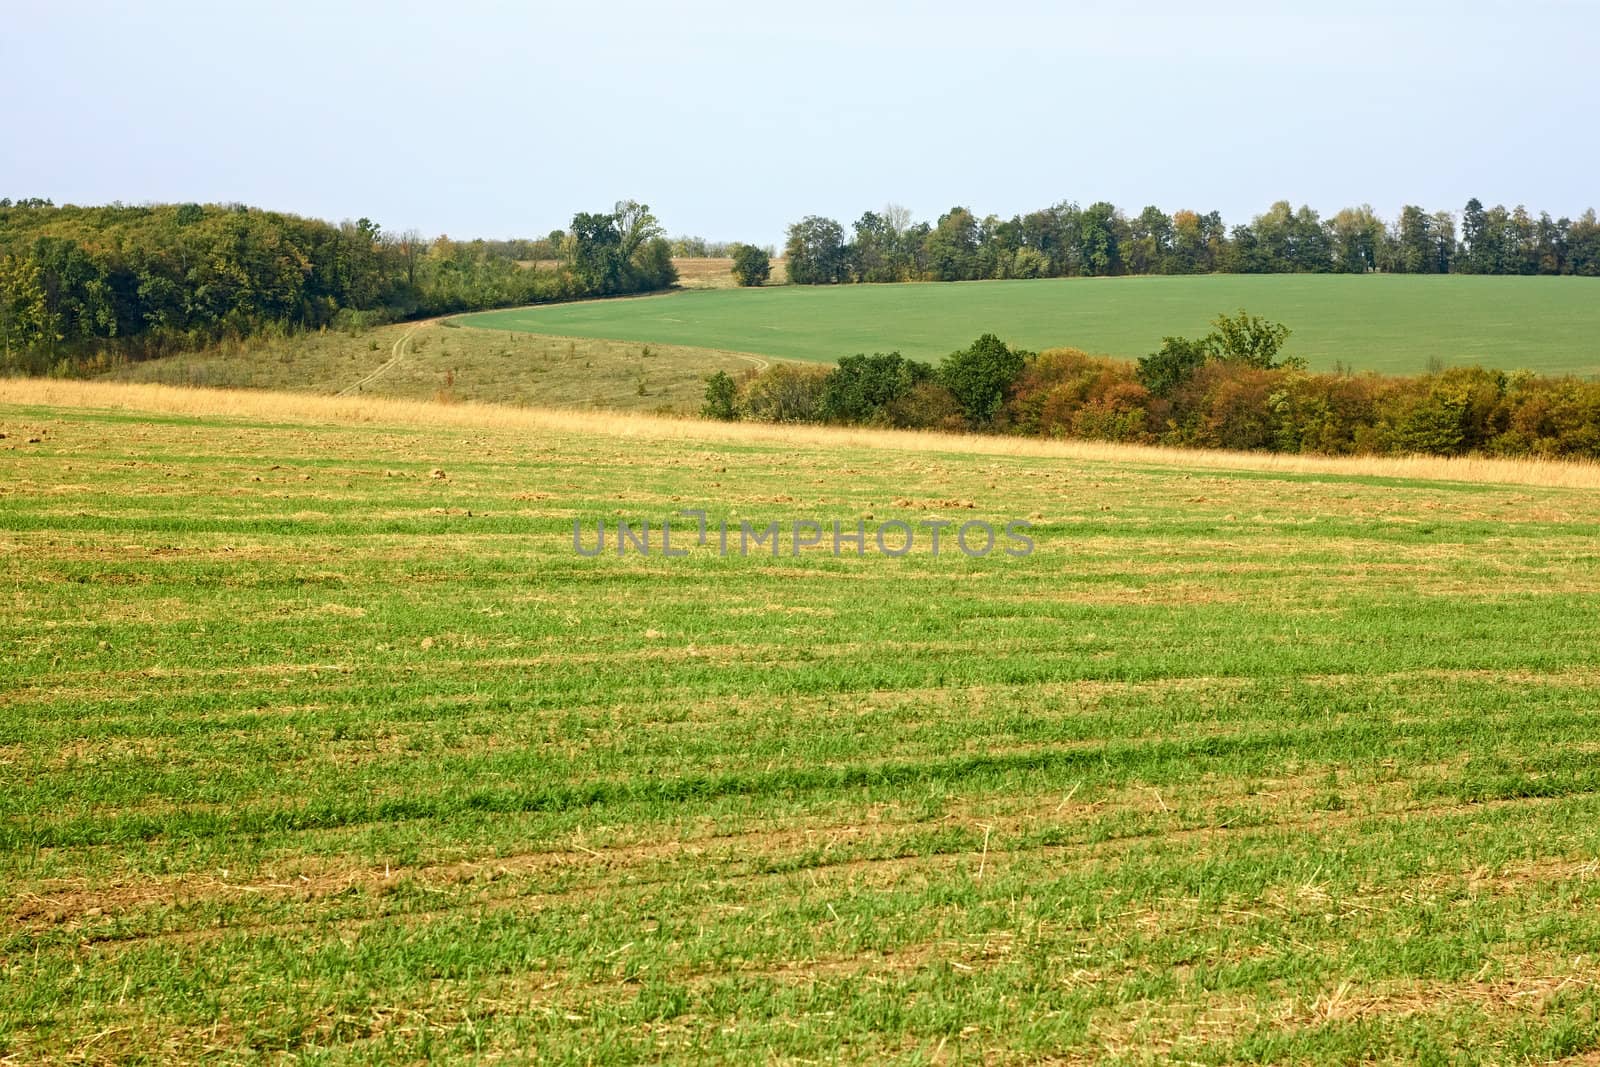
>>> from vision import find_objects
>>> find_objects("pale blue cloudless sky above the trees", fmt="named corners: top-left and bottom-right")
top-left (0, 0), bottom-right (1600, 243)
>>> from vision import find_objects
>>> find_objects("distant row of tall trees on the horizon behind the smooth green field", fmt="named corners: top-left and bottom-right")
top-left (786, 198), bottom-right (1600, 285)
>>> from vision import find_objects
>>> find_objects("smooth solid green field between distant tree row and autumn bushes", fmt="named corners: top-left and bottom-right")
top-left (461, 275), bottom-right (1600, 376)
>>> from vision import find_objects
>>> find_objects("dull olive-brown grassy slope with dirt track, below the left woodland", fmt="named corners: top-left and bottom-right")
top-left (109, 322), bottom-right (765, 413)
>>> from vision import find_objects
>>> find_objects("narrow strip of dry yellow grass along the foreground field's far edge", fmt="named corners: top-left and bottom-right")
top-left (0, 378), bottom-right (1600, 490)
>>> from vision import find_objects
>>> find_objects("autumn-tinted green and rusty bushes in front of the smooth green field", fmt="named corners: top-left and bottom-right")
top-left (702, 310), bottom-right (1600, 459)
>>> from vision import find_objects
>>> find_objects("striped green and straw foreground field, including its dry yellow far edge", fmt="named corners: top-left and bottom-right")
top-left (0, 382), bottom-right (1600, 1064)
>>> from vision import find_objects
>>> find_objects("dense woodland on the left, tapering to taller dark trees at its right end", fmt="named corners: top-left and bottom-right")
top-left (0, 198), bottom-right (677, 373)
